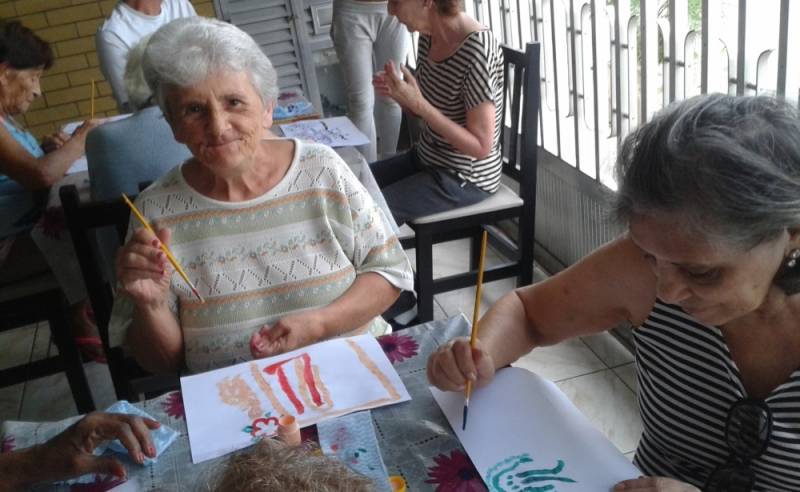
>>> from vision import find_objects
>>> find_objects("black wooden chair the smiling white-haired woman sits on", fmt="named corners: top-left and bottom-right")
top-left (59, 186), bottom-right (179, 401)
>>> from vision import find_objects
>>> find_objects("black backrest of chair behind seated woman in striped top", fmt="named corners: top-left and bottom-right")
top-left (500, 43), bottom-right (540, 194)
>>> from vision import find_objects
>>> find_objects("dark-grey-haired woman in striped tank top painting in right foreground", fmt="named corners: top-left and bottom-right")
top-left (428, 95), bottom-right (800, 492)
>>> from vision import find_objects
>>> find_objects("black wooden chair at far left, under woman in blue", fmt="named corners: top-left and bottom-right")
top-left (0, 272), bottom-right (95, 413)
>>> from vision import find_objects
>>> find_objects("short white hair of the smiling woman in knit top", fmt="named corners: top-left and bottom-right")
top-left (142, 17), bottom-right (278, 115)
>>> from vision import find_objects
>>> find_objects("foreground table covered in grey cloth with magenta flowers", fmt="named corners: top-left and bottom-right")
top-left (3, 315), bottom-right (485, 491)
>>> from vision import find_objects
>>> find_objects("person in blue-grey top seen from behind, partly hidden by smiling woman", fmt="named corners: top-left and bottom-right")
top-left (86, 36), bottom-right (192, 200)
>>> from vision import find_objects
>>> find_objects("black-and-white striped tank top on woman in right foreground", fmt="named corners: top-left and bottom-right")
top-left (634, 301), bottom-right (800, 492)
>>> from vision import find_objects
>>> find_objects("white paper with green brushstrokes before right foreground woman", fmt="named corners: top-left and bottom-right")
top-left (431, 367), bottom-right (641, 492)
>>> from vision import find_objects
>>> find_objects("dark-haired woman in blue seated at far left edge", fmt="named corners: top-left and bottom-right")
top-left (0, 21), bottom-right (102, 360)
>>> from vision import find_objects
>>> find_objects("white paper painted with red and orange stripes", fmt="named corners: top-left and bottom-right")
top-left (181, 335), bottom-right (411, 463)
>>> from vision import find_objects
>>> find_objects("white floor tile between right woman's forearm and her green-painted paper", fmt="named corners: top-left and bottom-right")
top-left (512, 338), bottom-right (606, 381)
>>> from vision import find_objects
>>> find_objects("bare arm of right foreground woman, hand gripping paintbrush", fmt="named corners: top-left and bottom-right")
top-left (428, 237), bottom-right (656, 390)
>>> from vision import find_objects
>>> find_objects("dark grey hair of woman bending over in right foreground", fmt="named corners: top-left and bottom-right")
top-left (614, 94), bottom-right (800, 254)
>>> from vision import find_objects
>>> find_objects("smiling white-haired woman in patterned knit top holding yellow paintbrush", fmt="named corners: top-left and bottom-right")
top-left (112, 18), bottom-right (413, 373)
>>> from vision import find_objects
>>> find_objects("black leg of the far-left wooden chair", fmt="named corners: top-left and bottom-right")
top-left (47, 300), bottom-right (95, 413)
